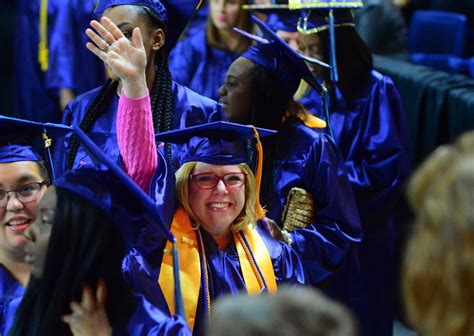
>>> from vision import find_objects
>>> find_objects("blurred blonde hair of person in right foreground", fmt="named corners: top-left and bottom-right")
top-left (402, 132), bottom-right (474, 336)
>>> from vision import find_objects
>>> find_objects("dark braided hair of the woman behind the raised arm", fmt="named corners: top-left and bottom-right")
top-left (66, 6), bottom-right (174, 170)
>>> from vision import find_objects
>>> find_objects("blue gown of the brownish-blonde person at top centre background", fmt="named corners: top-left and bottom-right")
top-left (169, 29), bottom-right (240, 100)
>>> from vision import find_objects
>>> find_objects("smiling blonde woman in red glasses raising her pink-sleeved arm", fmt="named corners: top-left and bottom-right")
top-left (78, 14), bottom-right (305, 335)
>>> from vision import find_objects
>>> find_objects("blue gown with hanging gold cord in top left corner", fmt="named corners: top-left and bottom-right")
top-left (14, 0), bottom-right (74, 122)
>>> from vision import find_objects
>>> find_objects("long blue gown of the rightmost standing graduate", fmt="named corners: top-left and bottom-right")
top-left (301, 71), bottom-right (410, 335)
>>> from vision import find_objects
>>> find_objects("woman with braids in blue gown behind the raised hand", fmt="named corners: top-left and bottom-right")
top-left (56, 0), bottom-right (220, 175)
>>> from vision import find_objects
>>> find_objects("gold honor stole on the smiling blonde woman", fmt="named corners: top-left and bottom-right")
top-left (158, 208), bottom-right (277, 330)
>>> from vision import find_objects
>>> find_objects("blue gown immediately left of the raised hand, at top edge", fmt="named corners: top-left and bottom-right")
top-left (70, 0), bottom-right (106, 95)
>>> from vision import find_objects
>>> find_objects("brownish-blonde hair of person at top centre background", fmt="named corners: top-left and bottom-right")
top-left (206, 0), bottom-right (252, 54)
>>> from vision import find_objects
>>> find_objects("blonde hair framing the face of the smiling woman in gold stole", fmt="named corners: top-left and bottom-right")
top-left (176, 161), bottom-right (258, 232)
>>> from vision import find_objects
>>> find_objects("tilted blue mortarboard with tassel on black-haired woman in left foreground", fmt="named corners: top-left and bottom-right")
top-left (69, 126), bottom-right (186, 318)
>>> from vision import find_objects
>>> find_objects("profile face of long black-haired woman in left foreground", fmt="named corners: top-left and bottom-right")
top-left (25, 187), bottom-right (57, 278)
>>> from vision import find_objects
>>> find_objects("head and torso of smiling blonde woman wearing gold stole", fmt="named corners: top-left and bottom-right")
top-left (150, 121), bottom-right (305, 335)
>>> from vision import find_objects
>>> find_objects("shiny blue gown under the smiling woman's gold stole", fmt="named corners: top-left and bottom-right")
top-left (122, 220), bottom-right (306, 335)
